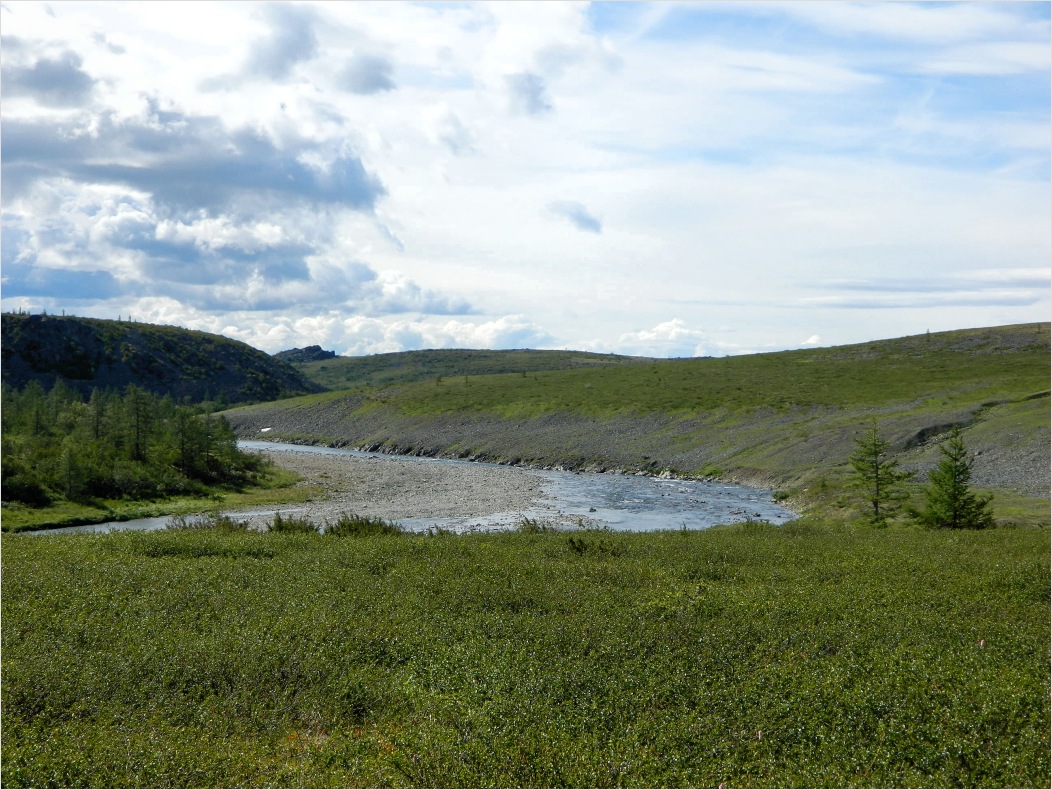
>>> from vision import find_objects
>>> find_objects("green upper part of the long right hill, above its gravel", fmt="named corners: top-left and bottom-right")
top-left (363, 324), bottom-right (1049, 418)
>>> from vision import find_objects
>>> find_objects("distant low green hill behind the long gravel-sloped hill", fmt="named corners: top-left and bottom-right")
top-left (294, 349), bottom-right (650, 390)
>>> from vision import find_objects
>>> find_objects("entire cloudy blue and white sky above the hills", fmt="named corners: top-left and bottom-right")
top-left (0, 0), bottom-right (1052, 357)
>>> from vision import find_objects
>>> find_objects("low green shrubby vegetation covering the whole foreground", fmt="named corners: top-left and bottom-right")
top-left (0, 520), bottom-right (1050, 787)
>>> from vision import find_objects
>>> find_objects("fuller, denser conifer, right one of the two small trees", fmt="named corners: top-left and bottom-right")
top-left (919, 428), bottom-right (994, 529)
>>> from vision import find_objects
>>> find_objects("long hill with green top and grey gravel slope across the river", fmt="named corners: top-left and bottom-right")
top-left (226, 323), bottom-right (1050, 509)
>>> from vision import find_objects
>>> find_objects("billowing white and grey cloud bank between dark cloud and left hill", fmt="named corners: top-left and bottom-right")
top-left (3, 189), bottom-right (473, 316)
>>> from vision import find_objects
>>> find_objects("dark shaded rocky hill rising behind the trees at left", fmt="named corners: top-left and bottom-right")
top-left (0, 313), bottom-right (319, 404)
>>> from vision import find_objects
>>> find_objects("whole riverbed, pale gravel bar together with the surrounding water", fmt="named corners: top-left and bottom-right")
top-left (28, 441), bottom-right (795, 534)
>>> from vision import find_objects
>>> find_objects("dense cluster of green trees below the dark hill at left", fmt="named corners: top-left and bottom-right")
top-left (0, 381), bottom-right (264, 507)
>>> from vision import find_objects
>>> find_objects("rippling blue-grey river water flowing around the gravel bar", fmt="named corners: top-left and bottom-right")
top-left (33, 441), bottom-right (796, 534)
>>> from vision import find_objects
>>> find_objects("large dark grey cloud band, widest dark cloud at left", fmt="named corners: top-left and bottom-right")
top-left (0, 108), bottom-right (386, 212)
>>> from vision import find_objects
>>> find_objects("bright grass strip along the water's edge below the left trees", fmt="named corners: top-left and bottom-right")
top-left (0, 466), bottom-right (322, 532)
